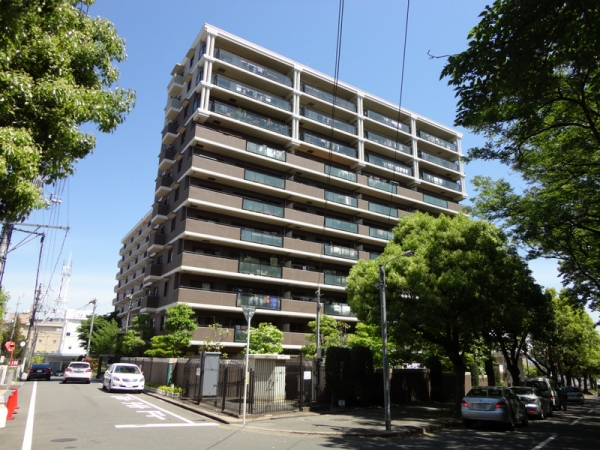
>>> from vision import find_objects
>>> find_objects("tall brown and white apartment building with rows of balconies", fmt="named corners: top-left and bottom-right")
top-left (113, 25), bottom-right (466, 355)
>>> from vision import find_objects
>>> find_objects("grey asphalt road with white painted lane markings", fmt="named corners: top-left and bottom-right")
top-left (0, 379), bottom-right (600, 450)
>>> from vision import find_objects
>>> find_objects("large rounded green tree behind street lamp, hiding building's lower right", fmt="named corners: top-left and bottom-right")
top-left (346, 213), bottom-right (540, 414)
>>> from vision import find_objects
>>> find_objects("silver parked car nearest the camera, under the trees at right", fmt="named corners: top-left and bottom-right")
top-left (461, 386), bottom-right (529, 430)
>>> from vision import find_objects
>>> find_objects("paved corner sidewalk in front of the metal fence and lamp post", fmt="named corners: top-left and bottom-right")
top-left (146, 392), bottom-right (461, 437)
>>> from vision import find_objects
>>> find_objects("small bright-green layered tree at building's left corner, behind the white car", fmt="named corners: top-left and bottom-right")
top-left (145, 303), bottom-right (198, 358)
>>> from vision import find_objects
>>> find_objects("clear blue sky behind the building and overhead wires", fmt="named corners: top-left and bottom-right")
top-left (3, 0), bottom-right (560, 313)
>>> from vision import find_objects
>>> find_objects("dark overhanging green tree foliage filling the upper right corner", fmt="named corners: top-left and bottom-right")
top-left (442, 0), bottom-right (600, 306)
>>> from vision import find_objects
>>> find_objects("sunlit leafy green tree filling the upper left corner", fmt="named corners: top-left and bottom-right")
top-left (0, 0), bottom-right (135, 222)
